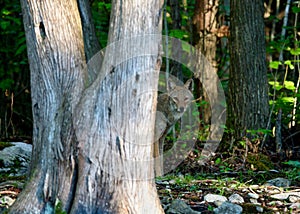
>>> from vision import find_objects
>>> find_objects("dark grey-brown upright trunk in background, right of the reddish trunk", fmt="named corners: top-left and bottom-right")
top-left (228, 0), bottom-right (269, 139)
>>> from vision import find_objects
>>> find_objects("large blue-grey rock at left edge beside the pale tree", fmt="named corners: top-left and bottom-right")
top-left (0, 143), bottom-right (32, 176)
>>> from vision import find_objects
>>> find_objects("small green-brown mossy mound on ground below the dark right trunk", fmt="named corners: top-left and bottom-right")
top-left (247, 153), bottom-right (274, 171)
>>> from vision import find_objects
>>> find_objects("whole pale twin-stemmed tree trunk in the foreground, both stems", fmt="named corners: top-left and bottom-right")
top-left (10, 0), bottom-right (163, 213)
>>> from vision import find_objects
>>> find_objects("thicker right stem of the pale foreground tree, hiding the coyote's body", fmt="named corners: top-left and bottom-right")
top-left (72, 0), bottom-right (163, 213)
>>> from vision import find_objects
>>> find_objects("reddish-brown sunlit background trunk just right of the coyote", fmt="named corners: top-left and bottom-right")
top-left (193, 0), bottom-right (226, 161)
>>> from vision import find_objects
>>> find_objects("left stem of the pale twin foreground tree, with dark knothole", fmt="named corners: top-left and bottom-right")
top-left (10, 0), bottom-right (86, 213)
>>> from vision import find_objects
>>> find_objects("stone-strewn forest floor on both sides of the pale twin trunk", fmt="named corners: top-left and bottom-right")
top-left (0, 143), bottom-right (300, 214)
